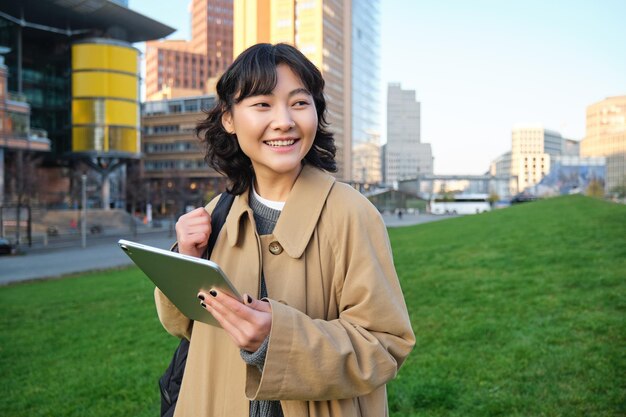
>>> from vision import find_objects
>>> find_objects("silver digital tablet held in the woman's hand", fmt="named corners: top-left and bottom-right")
top-left (117, 239), bottom-right (243, 326)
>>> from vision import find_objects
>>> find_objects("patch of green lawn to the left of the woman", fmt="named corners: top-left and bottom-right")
top-left (0, 269), bottom-right (177, 417)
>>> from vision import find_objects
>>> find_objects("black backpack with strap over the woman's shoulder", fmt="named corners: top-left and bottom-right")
top-left (159, 192), bottom-right (235, 417)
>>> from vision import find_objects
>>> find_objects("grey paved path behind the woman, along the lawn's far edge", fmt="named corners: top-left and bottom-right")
top-left (0, 214), bottom-right (450, 286)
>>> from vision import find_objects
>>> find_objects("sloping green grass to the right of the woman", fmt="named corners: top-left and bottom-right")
top-left (390, 196), bottom-right (626, 416)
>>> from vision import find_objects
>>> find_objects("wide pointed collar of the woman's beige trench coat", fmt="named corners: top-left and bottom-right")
top-left (226, 164), bottom-right (335, 258)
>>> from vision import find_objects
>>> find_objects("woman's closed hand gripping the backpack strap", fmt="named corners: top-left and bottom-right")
top-left (176, 207), bottom-right (211, 258)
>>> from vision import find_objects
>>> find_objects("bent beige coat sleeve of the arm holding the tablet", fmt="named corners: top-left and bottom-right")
top-left (246, 195), bottom-right (415, 401)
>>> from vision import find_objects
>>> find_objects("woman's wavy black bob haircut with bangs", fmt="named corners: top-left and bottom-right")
top-left (195, 43), bottom-right (337, 195)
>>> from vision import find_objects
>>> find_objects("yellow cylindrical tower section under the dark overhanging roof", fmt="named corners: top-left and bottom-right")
top-left (72, 39), bottom-right (141, 157)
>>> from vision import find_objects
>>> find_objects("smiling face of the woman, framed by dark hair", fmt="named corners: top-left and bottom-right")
top-left (222, 64), bottom-right (317, 185)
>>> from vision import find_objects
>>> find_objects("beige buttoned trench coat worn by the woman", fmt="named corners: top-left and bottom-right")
top-left (155, 165), bottom-right (415, 417)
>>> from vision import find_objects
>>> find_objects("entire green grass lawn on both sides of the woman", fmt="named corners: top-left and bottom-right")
top-left (0, 196), bottom-right (626, 417)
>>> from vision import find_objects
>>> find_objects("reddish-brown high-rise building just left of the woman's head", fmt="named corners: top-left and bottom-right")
top-left (146, 0), bottom-right (233, 100)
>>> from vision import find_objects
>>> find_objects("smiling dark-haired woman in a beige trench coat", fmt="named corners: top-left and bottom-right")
top-left (155, 44), bottom-right (415, 417)
